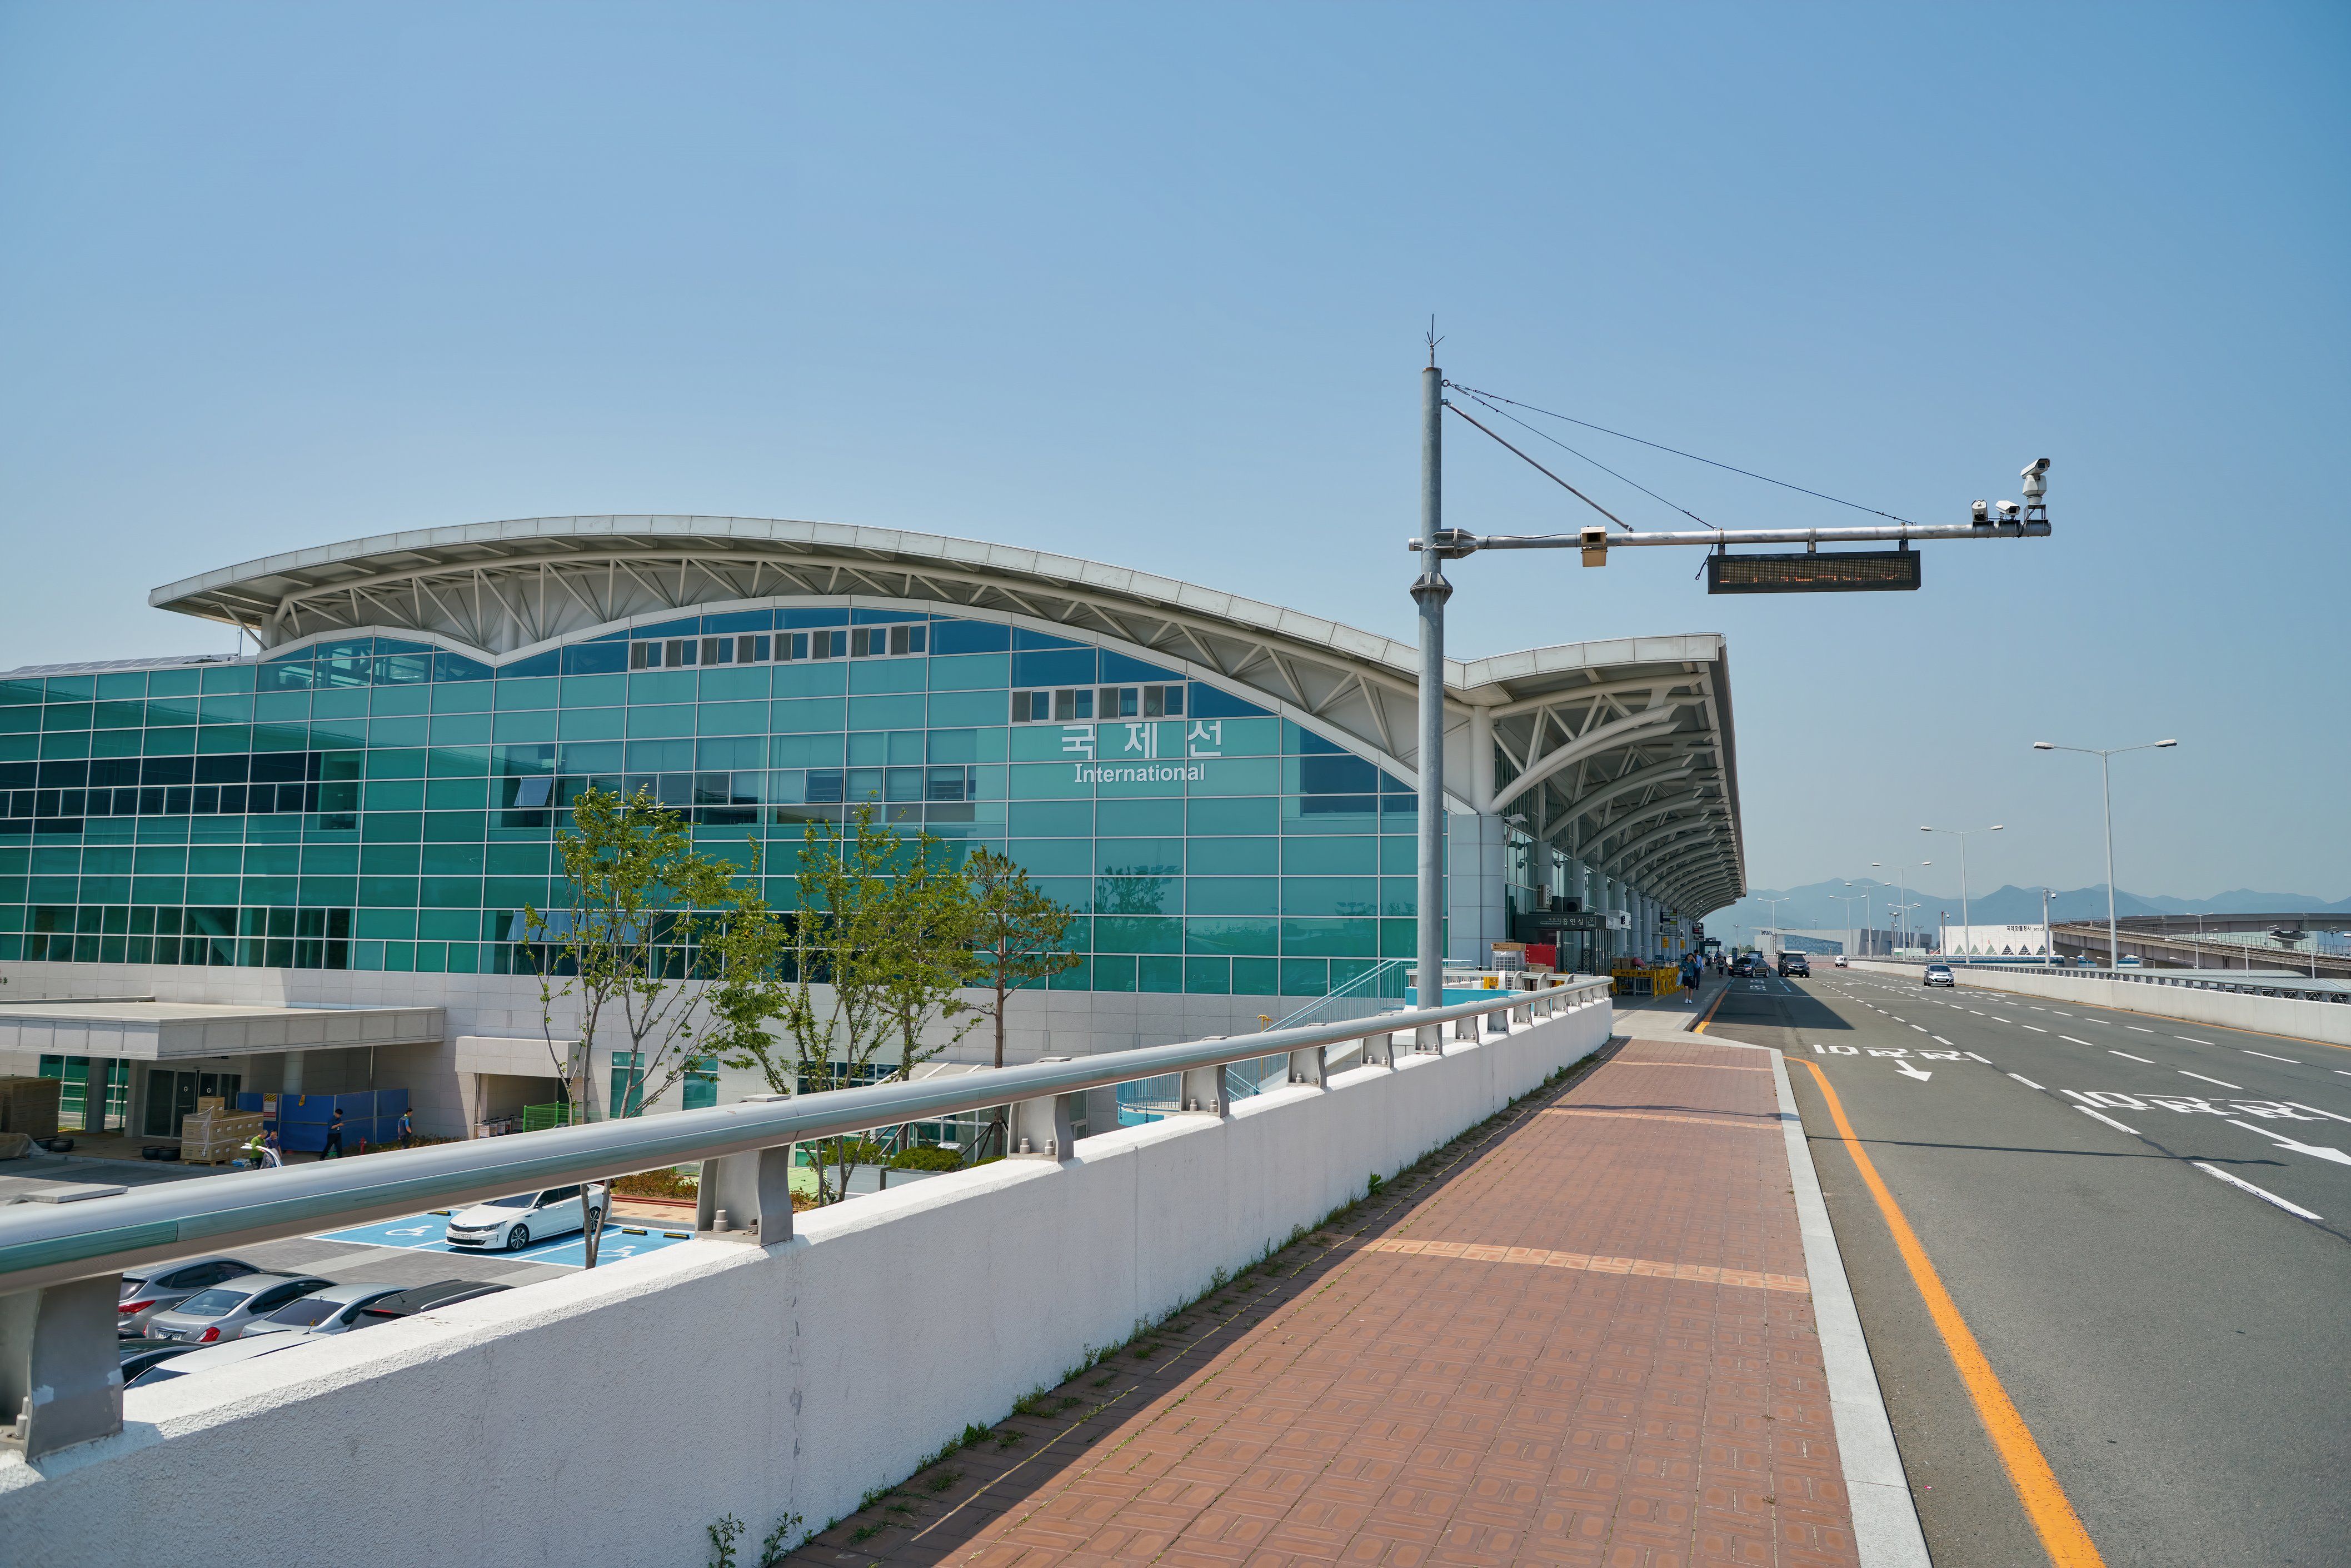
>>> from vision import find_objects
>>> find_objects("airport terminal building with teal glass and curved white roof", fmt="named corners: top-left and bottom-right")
top-left (0, 517), bottom-right (1744, 1138)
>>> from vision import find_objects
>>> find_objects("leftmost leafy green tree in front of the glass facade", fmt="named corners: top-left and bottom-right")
top-left (522, 790), bottom-right (729, 1267)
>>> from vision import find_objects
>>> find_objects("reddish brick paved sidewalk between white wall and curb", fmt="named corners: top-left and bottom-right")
top-left (792, 1037), bottom-right (1855, 1568)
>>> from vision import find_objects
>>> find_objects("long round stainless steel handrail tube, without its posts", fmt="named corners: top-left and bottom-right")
top-left (0, 980), bottom-right (1608, 1293)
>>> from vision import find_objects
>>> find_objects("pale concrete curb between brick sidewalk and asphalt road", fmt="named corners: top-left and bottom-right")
top-left (1704, 1035), bottom-right (1930, 1568)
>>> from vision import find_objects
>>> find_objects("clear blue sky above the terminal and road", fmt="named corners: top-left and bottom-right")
top-left (0, 4), bottom-right (2351, 898)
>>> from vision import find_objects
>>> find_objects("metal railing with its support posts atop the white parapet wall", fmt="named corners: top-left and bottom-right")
top-left (0, 980), bottom-right (1608, 1457)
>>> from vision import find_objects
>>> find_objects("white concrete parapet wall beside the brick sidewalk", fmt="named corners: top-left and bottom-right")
top-left (0, 999), bottom-right (1610, 1568)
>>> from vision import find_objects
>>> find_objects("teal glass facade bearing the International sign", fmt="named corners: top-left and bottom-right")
top-left (0, 600), bottom-right (1467, 997)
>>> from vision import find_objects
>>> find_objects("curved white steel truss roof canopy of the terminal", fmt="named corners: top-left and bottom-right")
top-left (148, 517), bottom-right (1744, 912)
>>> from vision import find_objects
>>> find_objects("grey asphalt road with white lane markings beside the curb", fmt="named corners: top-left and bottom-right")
top-left (1707, 968), bottom-right (2351, 1568)
